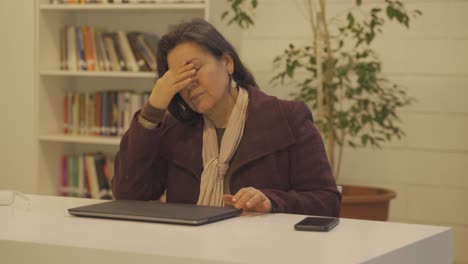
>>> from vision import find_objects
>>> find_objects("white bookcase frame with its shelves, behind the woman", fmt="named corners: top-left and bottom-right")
top-left (34, 0), bottom-right (231, 195)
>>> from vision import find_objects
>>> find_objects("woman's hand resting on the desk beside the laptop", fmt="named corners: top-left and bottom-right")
top-left (223, 187), bottom-right (271, 213)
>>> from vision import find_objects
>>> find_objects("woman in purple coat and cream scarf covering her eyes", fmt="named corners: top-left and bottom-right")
top-left (112, 20), bottom-right (341, 216)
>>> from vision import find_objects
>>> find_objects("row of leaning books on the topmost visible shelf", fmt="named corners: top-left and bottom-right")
top-left (60, 25), bottom-right (158, 72)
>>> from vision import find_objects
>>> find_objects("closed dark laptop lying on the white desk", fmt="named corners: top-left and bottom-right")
top-left (68, 200), bottom-right (242, 225)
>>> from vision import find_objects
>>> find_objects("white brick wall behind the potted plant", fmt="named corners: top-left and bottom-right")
top-left (234, 0), bottom-right (468, 263)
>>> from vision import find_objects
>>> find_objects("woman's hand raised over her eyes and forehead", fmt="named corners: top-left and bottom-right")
top-left (148, 62), bottom-right (196, 110)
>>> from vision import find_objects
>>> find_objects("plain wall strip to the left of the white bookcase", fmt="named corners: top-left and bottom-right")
top-left (0, 0), bottom-right (37, 192)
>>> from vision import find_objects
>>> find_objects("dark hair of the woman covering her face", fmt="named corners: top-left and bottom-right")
top-left (156, 19), bottom-right (257, 124)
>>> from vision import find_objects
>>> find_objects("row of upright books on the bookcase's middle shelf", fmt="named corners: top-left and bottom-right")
top-left (63, 90), bottom-right (150, 136)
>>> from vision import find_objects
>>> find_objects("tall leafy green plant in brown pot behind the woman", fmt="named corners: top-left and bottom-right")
top-left (222, 0), bottom-right (421, 220)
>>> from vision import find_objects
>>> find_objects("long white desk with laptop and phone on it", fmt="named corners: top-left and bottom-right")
top-left (0, 195), bottom-right (453, 264)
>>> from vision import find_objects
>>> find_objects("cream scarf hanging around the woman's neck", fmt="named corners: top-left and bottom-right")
top-left (197, 88), bottom-right (249, 206)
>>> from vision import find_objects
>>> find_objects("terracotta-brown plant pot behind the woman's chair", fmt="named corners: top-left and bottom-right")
top-left (340, 185), bottom-right (396, 221)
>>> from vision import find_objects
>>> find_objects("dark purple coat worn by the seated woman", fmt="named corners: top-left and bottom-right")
top-left (112, 88), bottom-right (341, 216)
